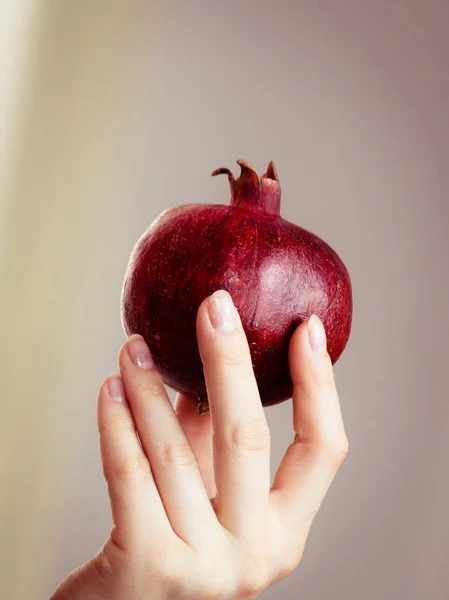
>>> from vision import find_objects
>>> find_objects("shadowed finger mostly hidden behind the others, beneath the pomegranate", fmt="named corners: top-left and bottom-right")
top-left (174, 394), bottom-right (217, 498)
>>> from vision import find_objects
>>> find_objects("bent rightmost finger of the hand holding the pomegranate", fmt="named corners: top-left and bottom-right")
top-left (272, 316), bottom-right (348, 531)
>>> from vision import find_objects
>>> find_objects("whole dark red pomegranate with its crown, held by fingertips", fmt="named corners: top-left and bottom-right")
top-left (122, 161), bottom-right (352, 406)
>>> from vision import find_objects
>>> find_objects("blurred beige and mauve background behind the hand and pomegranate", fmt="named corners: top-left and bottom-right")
top-left (0, 0), bottom-right (449, 600)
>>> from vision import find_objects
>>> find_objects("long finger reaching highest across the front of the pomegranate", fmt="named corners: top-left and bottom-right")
top-left (197, 291), bottom-right (270, 543)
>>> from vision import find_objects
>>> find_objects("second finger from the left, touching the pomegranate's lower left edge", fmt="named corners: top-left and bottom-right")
top-left (119, 335), bottom-right (217, 545)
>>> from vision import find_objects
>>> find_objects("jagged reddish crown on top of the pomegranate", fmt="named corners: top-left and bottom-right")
top-left (212, 160), bottom-right (281, 217)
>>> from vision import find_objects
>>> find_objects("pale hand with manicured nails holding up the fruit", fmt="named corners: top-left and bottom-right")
top-left (51, 291), bottom-right (348, 600)
